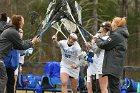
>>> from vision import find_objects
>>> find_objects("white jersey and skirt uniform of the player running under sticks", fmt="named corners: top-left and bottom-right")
top-left (58, 40), bottom-right (83, 79)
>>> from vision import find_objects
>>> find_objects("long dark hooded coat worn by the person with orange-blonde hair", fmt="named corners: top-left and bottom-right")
top-left (96, 26), bottom-right (129, 78)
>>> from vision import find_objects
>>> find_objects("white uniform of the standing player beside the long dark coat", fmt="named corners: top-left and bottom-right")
top-left (87, 36), bottom-right (109, 82)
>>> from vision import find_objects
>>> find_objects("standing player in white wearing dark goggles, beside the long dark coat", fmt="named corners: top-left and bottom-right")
top-left (86, 22), bottom-right (111, 93)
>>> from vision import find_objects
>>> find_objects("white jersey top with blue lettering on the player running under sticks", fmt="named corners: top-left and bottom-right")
top-left (58, 40), bottom-right (82, 68)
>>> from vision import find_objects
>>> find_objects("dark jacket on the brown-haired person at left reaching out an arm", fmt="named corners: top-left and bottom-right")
top-left (0, 26), bottom-right (32, 59)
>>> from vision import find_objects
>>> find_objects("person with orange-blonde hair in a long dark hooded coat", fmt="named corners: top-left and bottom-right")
top-left (96, 17), bottom-right (129, 93)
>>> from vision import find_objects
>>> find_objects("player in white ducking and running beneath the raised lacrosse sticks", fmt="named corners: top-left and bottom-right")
top-left (52, 33), bottom-right (85, 93)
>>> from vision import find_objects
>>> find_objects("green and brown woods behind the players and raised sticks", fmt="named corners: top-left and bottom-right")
top-left (0, 0), bottom-right (140, 79)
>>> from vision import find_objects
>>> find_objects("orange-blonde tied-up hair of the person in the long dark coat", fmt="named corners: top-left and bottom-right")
top-left (113, 17), bottom-right (126, 27)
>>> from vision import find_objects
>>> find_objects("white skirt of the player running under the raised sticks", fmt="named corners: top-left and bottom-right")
top-left (60, 65), bottom-right (80, 79)
